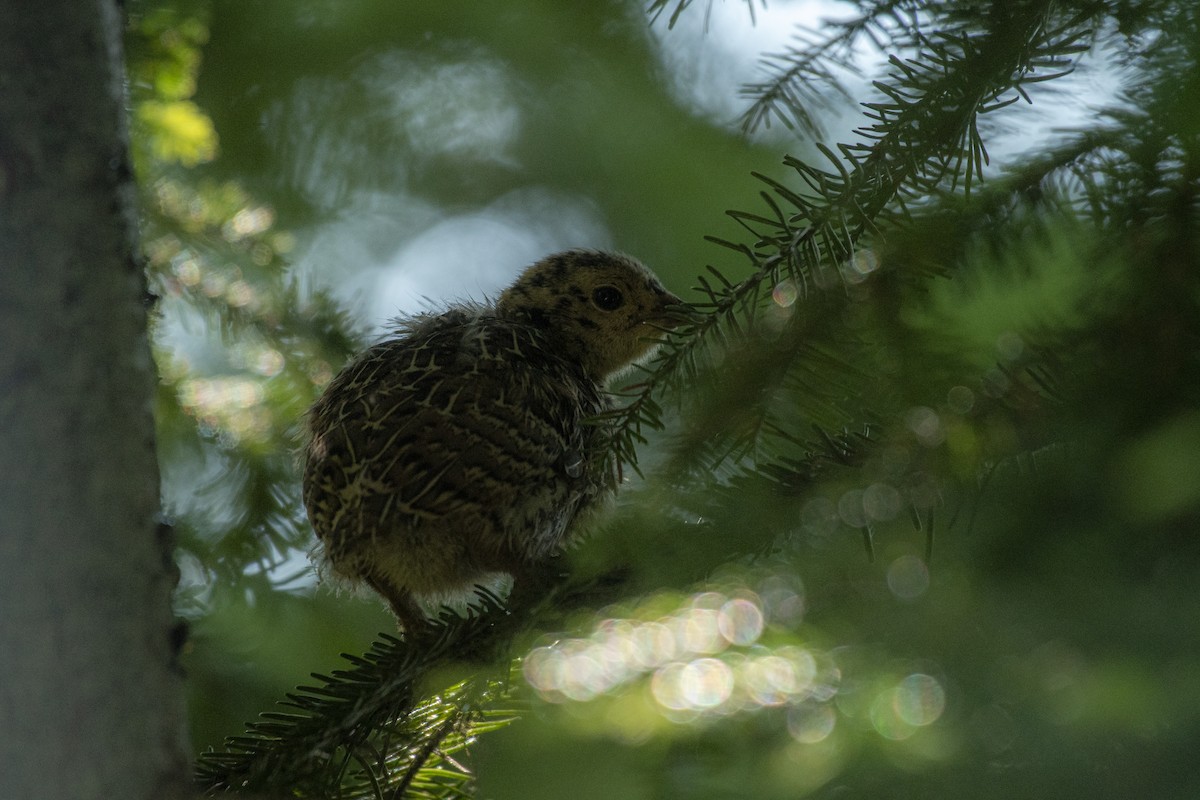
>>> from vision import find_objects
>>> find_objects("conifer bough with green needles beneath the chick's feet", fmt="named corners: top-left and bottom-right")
top-left (197, 597), bottom-right (516, 798)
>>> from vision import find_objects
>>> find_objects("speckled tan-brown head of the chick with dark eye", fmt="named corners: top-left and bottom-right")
top-left (496, 249), bottom-right (686, 381)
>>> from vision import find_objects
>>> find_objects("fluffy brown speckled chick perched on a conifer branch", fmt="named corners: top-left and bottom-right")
top-left (302, 249), bottom-right (688, 634)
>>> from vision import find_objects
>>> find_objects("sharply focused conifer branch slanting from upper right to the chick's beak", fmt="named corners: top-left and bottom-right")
top-left (606, 1), bottom-right (1090, 482)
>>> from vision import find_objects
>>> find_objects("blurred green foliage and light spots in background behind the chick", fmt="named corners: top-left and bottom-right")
top-left (127, 0), bottom-right (1200, 800)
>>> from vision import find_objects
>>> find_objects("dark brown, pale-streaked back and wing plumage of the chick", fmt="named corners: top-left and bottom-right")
top-left (306, 316), bottom-right (614, 554)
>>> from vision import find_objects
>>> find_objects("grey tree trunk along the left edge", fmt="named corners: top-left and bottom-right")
top-left (0, 0), bottom-right (187, 800)
